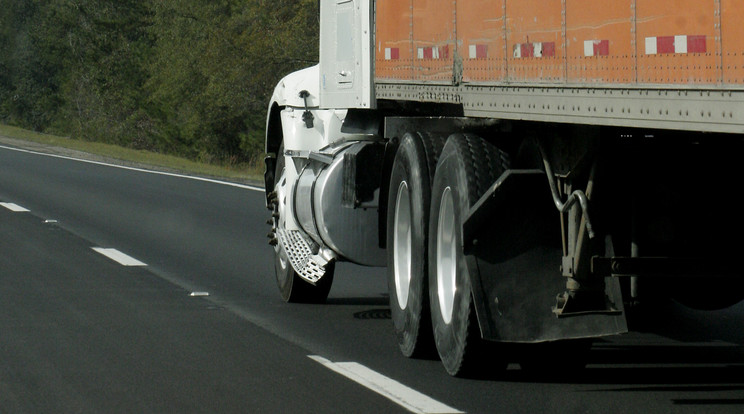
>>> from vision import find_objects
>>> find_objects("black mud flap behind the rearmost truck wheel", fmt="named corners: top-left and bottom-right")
top-left (463, 170), bottom-right (628, 343)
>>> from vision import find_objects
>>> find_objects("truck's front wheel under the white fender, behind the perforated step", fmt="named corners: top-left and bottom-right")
top-left (272, 146), bottom-right (335, 303)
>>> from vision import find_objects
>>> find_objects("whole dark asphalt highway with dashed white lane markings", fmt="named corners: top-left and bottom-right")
top-left (0, 141), bottom-right (744, 413)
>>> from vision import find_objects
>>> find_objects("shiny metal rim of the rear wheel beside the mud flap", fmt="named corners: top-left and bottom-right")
top-left (437, 187), bottom-right (457, 324)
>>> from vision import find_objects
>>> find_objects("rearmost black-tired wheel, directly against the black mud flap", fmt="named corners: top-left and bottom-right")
top-left (429, 134), bottom-right (508, 376)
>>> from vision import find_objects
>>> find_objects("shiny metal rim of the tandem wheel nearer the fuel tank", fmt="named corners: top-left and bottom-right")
top-left (393, 181), bottom-right (412, 309)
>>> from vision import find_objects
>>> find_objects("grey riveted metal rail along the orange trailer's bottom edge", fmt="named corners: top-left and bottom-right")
top-left (376, 82), bottom-right (744, 133)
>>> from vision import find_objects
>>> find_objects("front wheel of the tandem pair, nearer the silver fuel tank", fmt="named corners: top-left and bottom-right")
top-left (387, 134), bottom-right (444, 357)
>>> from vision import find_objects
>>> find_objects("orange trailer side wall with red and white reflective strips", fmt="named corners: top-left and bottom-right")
top-left (375, 0), bottom-right (744, 86)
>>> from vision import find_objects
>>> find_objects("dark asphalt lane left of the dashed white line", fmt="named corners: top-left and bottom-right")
top-left (0, 205), bottom-right (406, 413)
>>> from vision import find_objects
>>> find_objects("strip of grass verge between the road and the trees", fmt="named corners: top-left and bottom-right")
top-left (0, 124), bottom-right (263, 184)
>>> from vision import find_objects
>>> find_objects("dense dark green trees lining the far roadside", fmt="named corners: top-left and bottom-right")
top-left (0, 0), bottom-right (318, 162)
